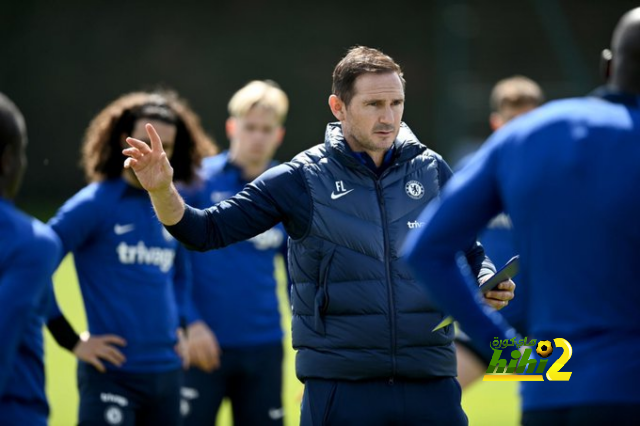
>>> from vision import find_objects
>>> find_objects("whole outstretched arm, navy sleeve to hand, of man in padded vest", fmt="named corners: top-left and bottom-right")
top-left (123, 125), bottom-right (311, 251)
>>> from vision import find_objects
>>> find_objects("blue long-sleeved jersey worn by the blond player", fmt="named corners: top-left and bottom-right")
top-left (186, 152), bottom-right (287, 348)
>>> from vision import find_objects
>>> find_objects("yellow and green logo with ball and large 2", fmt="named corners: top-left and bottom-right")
top-left (482, 337), bottom-right (573, 382)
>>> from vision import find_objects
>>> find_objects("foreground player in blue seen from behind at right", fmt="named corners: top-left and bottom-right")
top-left (407, 8), bottom-right (640, 426)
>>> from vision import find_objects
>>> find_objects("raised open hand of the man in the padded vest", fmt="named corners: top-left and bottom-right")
top-left (122, 124), bottom-right (173, 192)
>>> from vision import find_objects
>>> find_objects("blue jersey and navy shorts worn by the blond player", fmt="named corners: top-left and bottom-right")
top-left (182, 152), bottom-right (287, 426)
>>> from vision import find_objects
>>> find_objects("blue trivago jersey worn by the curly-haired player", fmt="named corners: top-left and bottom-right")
top-left (49, 178), bottom-right (190, 373)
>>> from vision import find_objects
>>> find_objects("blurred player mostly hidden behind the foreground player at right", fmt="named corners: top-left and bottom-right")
top-left (456, 75), bottom-right (544, 389)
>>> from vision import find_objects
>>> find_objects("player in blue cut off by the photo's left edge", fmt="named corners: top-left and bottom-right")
top-left (0, 93), bottom-right (60, 426)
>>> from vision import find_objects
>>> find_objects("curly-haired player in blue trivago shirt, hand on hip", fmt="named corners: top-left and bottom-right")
top-left (50, 92), bottom-right (214, 425)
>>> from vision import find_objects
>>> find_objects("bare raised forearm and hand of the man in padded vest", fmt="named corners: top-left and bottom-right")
top-left (122, 124), bottom-right (185, 225)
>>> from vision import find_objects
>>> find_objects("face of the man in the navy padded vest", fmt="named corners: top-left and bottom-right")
top-left (338, 72), bottom-right (404, 152)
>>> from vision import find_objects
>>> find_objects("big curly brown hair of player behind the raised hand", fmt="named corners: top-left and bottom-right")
top-left (81, 90), bottom-right (217, 183)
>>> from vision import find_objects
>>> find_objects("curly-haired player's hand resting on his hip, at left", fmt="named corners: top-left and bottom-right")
top-left (73, 333), bottom-right (127, 373)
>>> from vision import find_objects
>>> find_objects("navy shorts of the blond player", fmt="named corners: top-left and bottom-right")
top-left (182, 342), bottom-right (284, 426)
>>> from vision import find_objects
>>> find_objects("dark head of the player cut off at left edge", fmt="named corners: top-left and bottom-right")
top-left (0, 93), bottom-right (26, 199)
